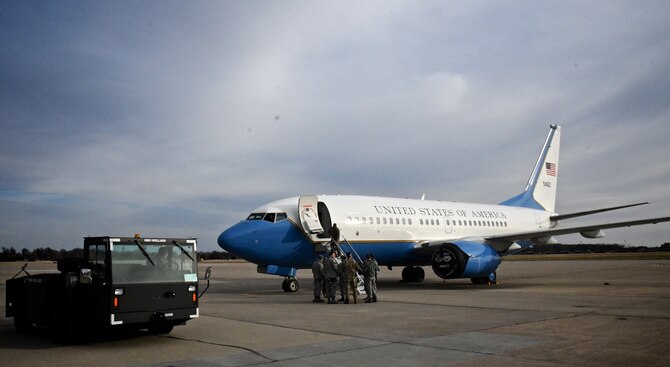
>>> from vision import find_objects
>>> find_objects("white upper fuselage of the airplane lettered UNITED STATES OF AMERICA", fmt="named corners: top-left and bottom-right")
top-left (254, 195), bottom-right (552, 243)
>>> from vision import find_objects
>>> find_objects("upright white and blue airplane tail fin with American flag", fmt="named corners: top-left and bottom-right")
top-left (500, 125), bottom-right (561, 212)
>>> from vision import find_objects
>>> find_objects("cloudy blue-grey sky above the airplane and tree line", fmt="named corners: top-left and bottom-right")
top-left (0, 0), bottom-right (670, 251)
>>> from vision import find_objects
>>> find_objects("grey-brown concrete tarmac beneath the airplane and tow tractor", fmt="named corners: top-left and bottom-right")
top-left (0, 260), bottom-right (670, 367)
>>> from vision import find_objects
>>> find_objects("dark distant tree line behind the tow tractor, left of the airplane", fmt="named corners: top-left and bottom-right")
top-left (0, 247), bottom-right (236, 261)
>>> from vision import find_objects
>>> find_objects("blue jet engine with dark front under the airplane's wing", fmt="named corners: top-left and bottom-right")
top-left (431, 241), bottom-right (501, 279)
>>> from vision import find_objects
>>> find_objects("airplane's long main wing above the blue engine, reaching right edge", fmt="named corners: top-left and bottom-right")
top-left (485, 217), bottom-right (670, 251)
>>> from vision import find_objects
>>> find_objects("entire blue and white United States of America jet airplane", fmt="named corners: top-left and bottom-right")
top-left (217, 124), bottom-right (670, 292)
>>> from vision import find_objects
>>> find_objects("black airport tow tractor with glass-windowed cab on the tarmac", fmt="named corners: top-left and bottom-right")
top-left (6, 235), bottom-right (211, 337)
